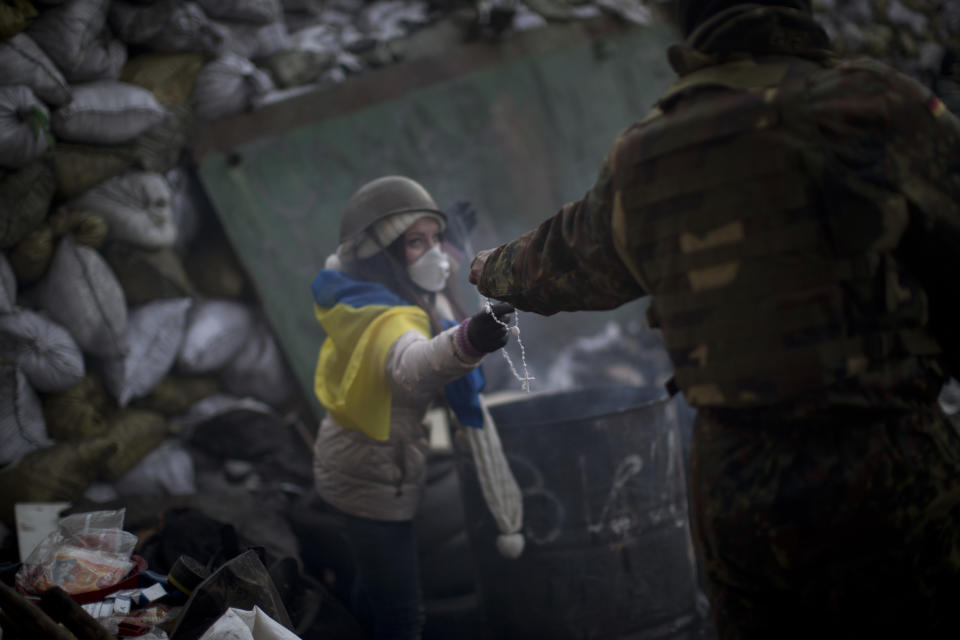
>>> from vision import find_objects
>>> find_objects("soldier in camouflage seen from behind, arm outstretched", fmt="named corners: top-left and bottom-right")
top-left (470, 0), bottom-right (960, 639)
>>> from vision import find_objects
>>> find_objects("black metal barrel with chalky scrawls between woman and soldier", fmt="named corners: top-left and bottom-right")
top-left (456, 387), bottom-right (700, 640)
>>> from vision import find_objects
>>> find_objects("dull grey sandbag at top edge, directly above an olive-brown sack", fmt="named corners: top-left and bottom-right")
top-left (110, 0), bottom-right (227, 53)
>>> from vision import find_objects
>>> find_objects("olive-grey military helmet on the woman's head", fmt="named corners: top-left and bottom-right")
top-left (340, 176), bottom-right (447, 243)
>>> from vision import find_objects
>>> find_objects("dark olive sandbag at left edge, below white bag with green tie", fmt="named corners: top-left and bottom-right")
top-left (0, 160), bottom-right (54, 249)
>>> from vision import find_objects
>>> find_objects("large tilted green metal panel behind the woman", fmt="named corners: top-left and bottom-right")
top-left (194, 20), bottom-right (676, 418)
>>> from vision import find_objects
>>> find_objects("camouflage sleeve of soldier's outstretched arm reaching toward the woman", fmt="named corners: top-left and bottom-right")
top-left (477, 134), bottom-right (644, 315)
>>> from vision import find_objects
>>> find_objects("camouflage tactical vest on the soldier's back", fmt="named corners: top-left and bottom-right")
top-left (613, 61), bottom-right (939, 407)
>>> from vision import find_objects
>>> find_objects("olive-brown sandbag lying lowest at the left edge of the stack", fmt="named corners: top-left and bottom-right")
top-left (0, 438), bottom-right (117, 523)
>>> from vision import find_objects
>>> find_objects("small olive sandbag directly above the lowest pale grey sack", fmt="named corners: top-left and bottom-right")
top-left (100, 409), bottom-right (170, 482)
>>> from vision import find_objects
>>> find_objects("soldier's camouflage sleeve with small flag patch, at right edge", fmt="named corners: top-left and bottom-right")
top-left (884, 63), bottom-right (960, 377)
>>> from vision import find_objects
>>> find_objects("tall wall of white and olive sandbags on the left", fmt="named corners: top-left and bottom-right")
top-left (0, 0), bottom-right (295, 518)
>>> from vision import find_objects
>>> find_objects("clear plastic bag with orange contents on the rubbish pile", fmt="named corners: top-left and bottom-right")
top-left (16, 509), bottom-right (137, 593)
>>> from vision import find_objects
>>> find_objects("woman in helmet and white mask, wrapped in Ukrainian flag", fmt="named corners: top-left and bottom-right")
top-left (312, 176), bottom-right (513, 640)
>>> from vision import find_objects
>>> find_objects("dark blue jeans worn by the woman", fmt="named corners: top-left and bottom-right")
top-left (344, 514), bottom-right (423, 640)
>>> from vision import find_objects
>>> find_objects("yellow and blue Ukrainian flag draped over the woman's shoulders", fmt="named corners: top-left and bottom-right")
top-left (311, 269), bottom-right (484, 441)
